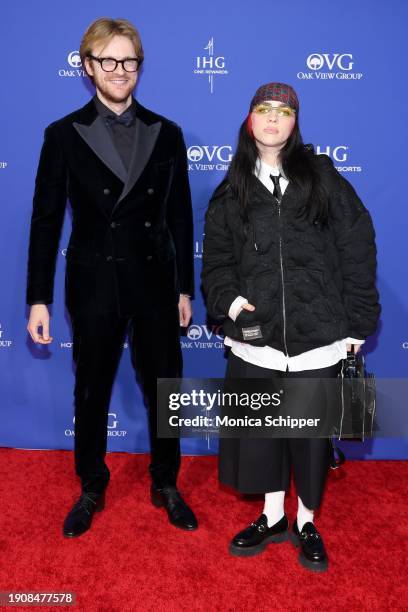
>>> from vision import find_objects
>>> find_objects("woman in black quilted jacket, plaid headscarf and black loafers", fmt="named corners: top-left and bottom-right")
top-left (202, 83), bottom-right (380, 571)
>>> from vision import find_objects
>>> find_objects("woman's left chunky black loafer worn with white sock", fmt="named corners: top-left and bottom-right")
top-left (229, 514), bottom-right (289, 557)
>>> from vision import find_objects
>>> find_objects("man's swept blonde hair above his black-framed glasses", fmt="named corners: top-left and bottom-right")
top-left (79, 17), bottom-right (144, 67)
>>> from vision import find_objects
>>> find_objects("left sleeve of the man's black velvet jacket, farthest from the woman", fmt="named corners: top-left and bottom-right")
top-left (27, 126), bottom-right (67, 305)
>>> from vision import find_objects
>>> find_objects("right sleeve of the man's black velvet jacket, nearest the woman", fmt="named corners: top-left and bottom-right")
top-left (166, 128), bottom-right (194, 298)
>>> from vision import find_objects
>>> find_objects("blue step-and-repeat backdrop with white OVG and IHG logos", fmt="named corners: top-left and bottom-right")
top-left (0, 0), bottom-right (408, 459)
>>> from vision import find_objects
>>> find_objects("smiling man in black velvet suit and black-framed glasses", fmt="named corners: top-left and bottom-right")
top-left (27, 18), bottom-right (197, 537)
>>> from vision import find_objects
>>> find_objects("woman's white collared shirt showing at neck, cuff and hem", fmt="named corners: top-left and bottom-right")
top-left (224, 159), bottom-right (364, 372)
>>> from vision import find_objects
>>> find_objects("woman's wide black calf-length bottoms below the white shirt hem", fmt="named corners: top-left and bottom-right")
top-left (219, 351), bottom-right (341, 509)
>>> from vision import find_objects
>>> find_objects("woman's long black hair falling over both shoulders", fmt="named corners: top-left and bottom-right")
top-left (214, 112), bottom-right (328, 225)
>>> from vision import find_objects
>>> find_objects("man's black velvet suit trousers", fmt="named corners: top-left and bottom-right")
top-left (71, 305), bottom-right (182, 492)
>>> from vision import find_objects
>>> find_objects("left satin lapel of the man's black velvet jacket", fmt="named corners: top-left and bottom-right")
top-left (73, 101), bottom-right (128, 183)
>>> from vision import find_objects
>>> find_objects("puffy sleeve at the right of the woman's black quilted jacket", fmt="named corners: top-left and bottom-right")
top-left (329, 163), bottom-right (381, 339)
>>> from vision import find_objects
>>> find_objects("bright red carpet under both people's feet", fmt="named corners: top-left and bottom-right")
top-left (0, 449), bottom-right (408, 612)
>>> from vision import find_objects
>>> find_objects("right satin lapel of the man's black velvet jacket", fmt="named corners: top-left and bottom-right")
top-left (117, 117), bottom-right (162, 204)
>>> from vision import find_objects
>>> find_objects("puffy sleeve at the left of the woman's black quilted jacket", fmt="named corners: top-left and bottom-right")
top-left (201, 198), bottom-right (240, 319)
